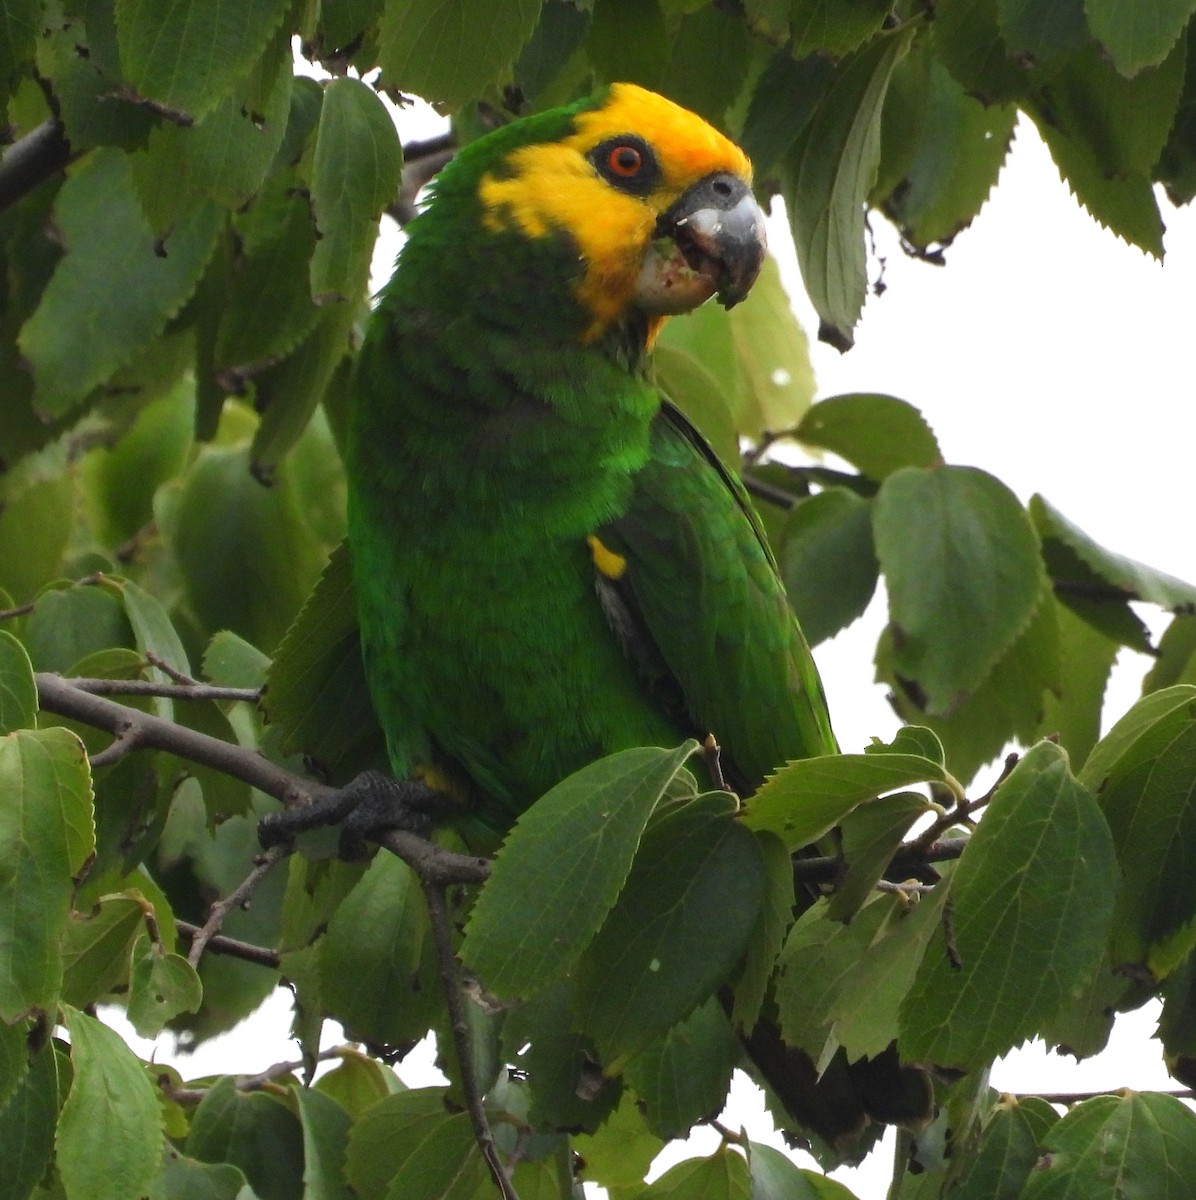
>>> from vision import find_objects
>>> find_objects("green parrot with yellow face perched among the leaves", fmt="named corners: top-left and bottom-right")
top-left (345, 83), bottom-right (928, 1138)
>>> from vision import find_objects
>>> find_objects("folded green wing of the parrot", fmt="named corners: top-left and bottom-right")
top-left (599, 403), bottom-right (837, 791)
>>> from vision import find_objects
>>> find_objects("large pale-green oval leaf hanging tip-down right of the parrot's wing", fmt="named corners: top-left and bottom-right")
top-left (873, 467), bottom-right (1045, 715)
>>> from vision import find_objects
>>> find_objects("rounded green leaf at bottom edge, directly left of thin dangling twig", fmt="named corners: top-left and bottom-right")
top-left (345, 1087), bottom-right (487, 1200)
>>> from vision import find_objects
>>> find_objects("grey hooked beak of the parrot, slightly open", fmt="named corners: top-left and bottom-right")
top-left (636, 173), bottom-right (768, 313)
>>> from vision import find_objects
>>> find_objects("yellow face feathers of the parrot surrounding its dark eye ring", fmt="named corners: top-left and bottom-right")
top-left (480, 83), bottom-right (752, 341)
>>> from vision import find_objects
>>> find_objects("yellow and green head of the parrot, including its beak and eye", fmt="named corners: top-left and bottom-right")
top-left (405, 84), bottom-right (765, 342)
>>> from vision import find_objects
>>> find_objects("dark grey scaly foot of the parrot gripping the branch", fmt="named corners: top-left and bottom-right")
top-left (258, 770), bottom-right (452, 862)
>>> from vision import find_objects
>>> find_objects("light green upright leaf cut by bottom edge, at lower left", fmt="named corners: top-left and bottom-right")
top-left (55, 1008), bottom-right (162, 1200)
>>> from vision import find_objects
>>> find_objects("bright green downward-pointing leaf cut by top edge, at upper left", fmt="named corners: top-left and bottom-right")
top-left (116, 0), bottom-right (288, 120)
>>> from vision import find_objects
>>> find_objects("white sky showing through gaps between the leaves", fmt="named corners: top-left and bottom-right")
top-left (142, 105), bottom-right (1196, 1200)
